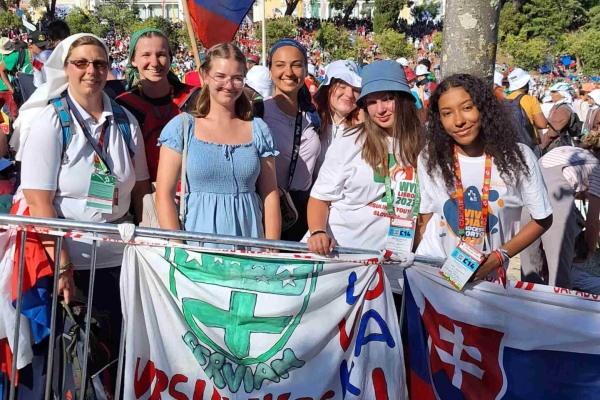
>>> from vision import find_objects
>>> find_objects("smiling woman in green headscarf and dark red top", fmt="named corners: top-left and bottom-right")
top-left (117, 28), bottom-right (199, 182)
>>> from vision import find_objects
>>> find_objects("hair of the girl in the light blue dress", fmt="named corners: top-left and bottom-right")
top-left (190, 43), bottom-right (253, 121)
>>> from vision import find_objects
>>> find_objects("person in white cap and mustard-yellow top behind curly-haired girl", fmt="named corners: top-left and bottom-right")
top-left (506, 68), bottom-right (548, 138)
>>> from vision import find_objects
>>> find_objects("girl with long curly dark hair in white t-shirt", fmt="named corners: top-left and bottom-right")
top-left (417, 74), bottom-right (552, 279)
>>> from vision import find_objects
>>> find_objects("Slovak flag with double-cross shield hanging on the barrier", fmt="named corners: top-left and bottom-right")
top-left (402, 265), bottom-right (600, 400)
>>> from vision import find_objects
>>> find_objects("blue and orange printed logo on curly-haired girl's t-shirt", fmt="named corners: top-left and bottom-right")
top-left (440, 186), bottom-right (504, 246)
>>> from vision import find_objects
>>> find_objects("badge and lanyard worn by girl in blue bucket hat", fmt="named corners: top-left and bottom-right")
top-left (385, 163), bottom-right (421, 254)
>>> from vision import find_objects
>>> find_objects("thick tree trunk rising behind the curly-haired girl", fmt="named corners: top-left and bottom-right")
top-left (441, 0), bottom-right (500, 78)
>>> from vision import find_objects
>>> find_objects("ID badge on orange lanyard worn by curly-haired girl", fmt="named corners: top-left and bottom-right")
top-left (440, 147), bottom-right (492, 290)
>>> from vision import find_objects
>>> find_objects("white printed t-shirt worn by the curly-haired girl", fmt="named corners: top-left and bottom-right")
top-left (417, 144), bottom-right (552, 258)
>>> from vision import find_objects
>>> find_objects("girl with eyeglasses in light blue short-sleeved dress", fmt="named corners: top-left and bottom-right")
top-left (156, 43), bottom-right (281, 247)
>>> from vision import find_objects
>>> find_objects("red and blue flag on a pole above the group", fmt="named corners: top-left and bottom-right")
top-left (185, 0), bottom-right (254, 48)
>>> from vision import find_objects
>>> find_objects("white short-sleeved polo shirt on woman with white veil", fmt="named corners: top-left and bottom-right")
top-left (21, 90), bottom-right (150, 269)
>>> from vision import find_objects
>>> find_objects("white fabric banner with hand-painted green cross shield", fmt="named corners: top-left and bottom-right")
top-left (121, 246), bottom-right (406, 400)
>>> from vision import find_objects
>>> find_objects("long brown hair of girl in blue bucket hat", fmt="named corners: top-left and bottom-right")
top-left (356, 92), bottom-right (423, 175)
